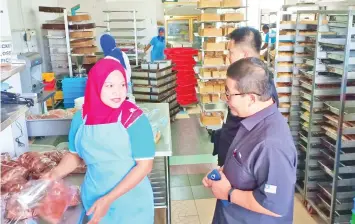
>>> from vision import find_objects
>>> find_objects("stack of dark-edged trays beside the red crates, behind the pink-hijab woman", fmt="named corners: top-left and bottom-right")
top-left (131, 61), bottom-right (180, 118)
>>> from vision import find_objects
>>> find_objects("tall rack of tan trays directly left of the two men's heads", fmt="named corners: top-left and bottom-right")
top-left (195, 0), bottom-right (248, 130)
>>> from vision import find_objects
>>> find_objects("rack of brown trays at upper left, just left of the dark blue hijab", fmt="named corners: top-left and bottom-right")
top-left (68, 14), bottom-right (97, 75)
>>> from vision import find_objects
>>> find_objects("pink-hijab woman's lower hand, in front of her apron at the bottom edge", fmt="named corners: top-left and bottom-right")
top-left (86, 196), bottom-right (112, 224)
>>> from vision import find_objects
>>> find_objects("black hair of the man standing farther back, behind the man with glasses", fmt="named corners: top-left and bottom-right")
top-left (229, 26), bottom-right (262, 54)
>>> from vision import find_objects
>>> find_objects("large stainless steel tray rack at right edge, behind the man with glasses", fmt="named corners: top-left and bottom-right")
top-left (291, 10), bottom-right (355, 224)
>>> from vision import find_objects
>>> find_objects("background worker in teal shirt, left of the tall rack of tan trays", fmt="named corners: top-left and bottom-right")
top-left (144, 28), bottom-right (165, 62)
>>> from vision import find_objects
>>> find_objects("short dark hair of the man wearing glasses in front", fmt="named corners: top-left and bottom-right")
top-left (227, 58), bottom-right (272, 102)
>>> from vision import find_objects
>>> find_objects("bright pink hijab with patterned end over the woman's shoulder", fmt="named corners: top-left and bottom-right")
top-left (83, 58), bottom-right (143, 128)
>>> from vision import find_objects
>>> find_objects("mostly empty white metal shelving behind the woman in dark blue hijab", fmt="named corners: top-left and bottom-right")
top-left (103, 10), bottom-right (146, 66)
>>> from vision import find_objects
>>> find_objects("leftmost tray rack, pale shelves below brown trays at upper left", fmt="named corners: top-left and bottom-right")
top-left (39, 6), bottom-right (69, 76)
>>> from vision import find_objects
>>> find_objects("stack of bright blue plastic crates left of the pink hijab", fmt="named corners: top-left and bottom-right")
top-left (62, 78), bottom-right (87, 108)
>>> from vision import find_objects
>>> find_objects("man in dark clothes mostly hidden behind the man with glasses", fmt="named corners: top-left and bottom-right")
top-left (211, 27), bottom-right (279, 166)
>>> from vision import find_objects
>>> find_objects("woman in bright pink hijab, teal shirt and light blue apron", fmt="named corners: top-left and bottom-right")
top-left (46, 59), bottom-right (155, 224)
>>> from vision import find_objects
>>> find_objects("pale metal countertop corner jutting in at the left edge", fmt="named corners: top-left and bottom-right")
top-left (0, 104), bottom-right (29, 131)
